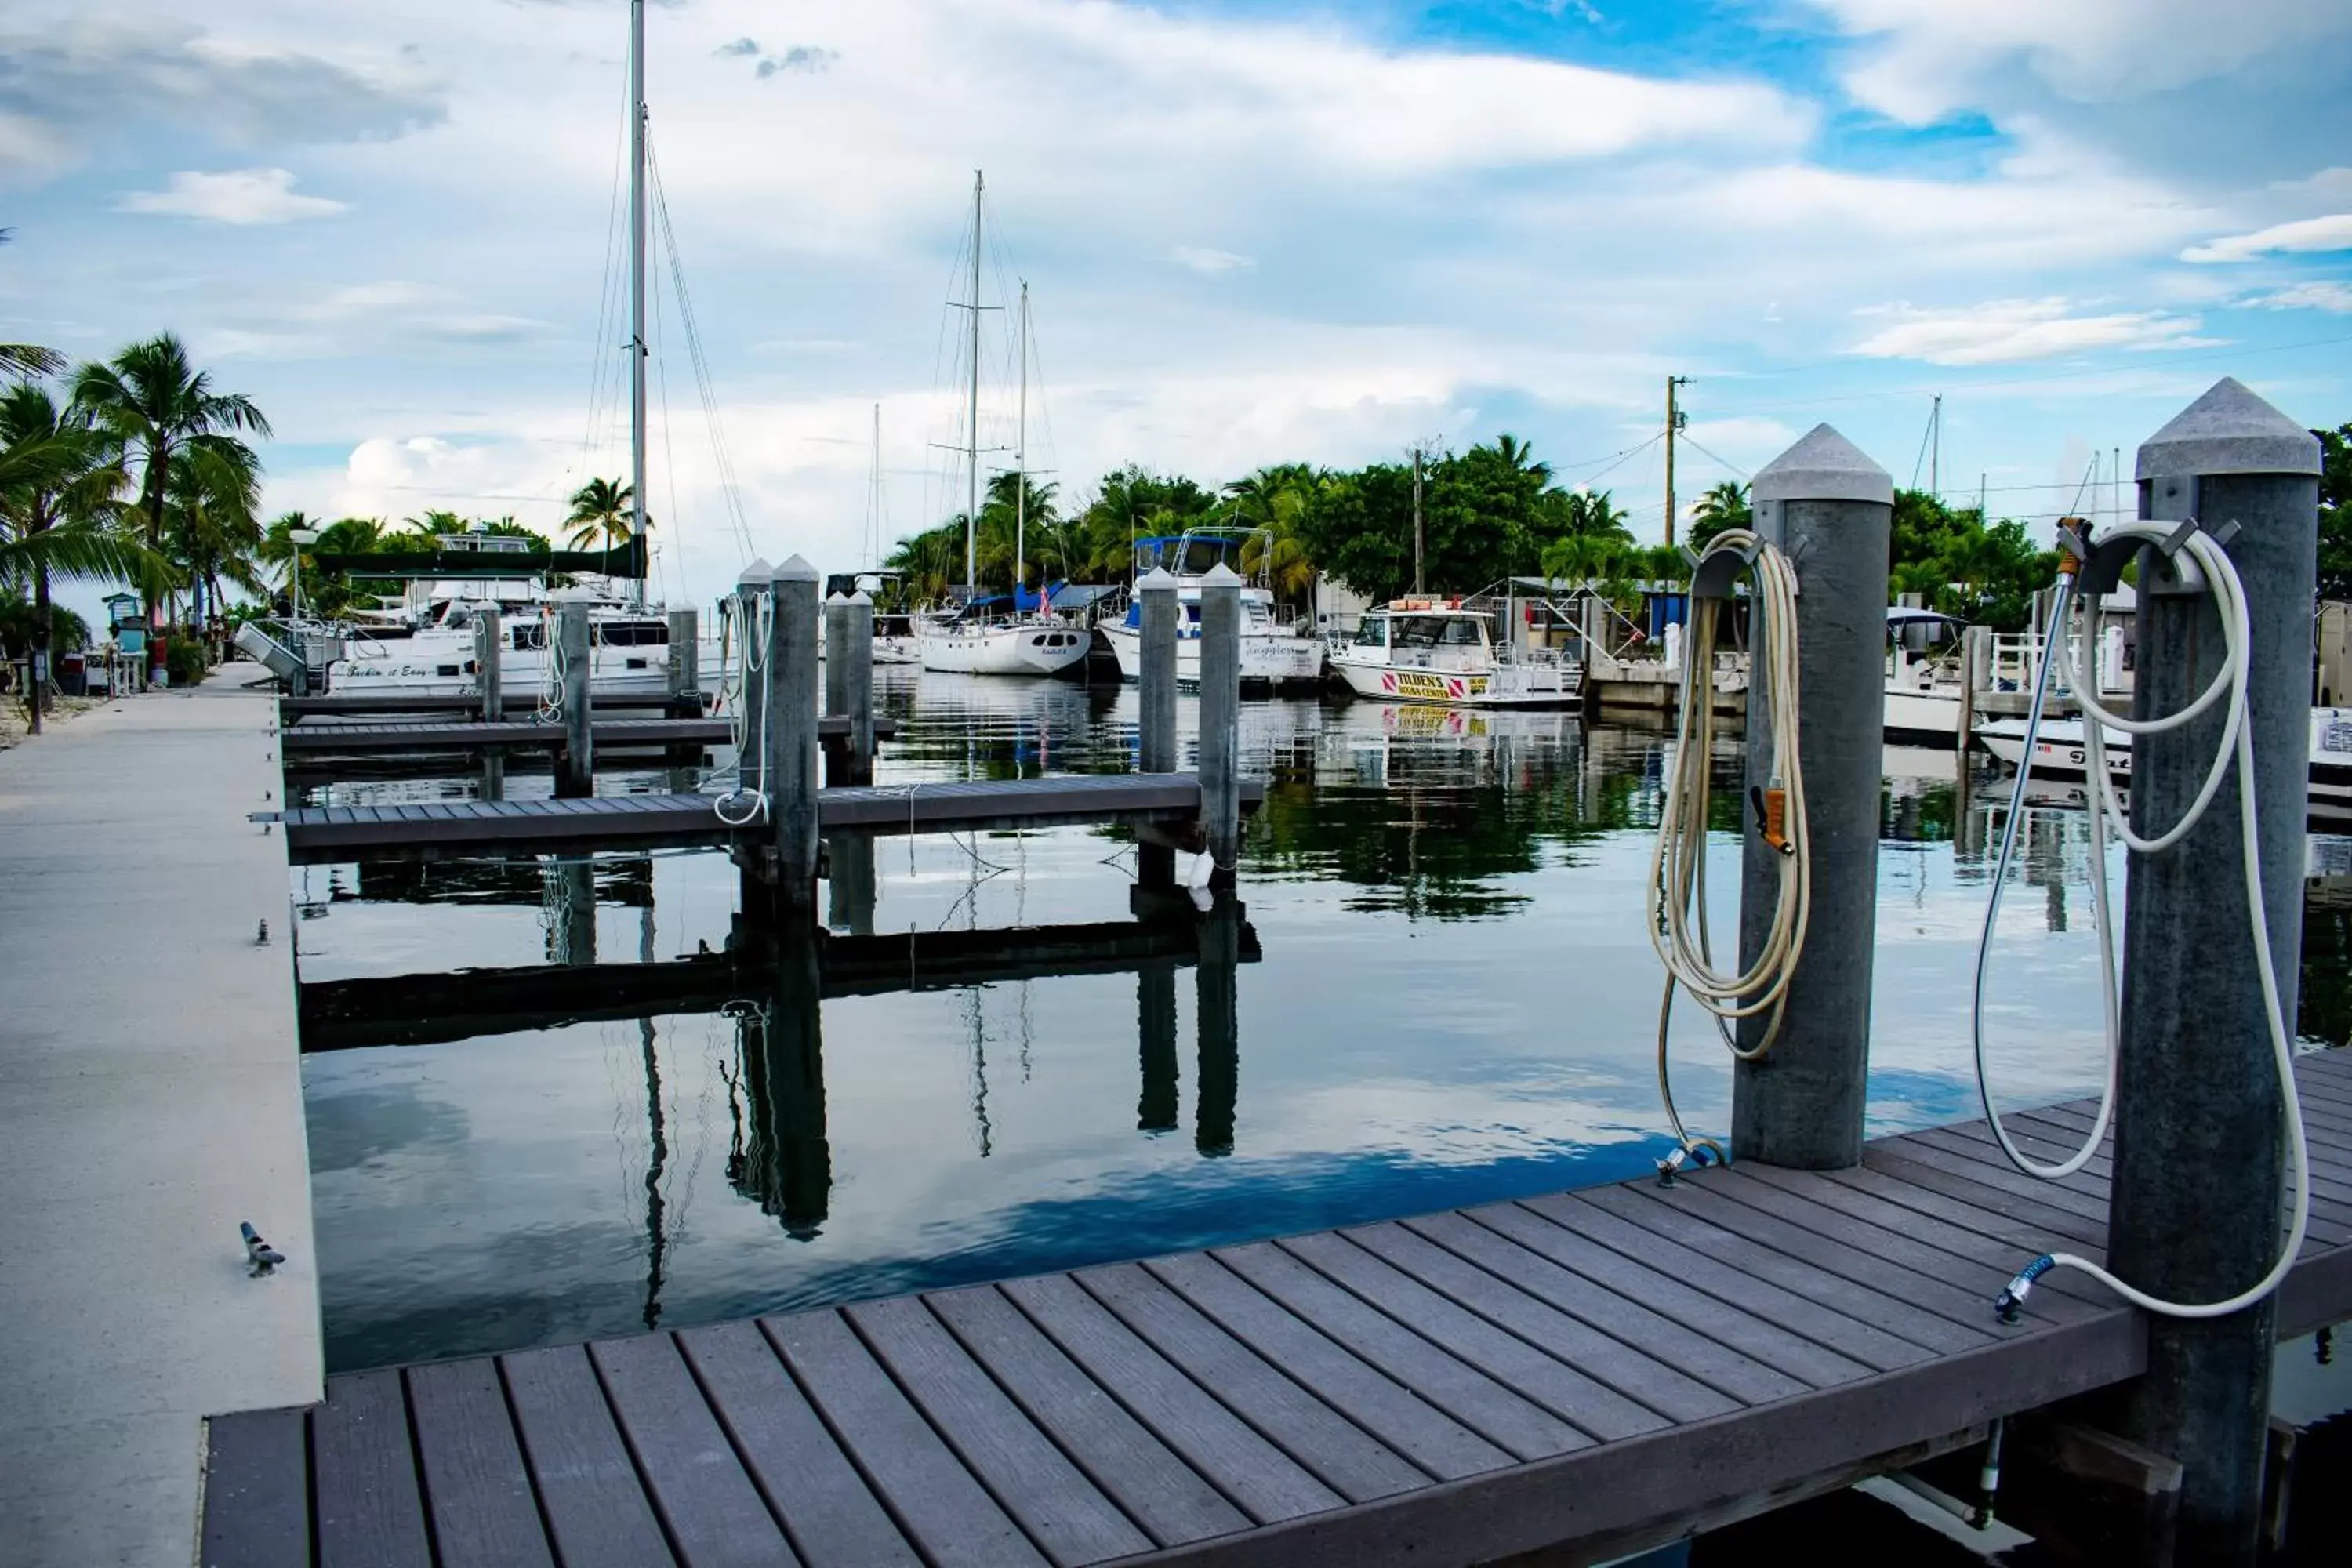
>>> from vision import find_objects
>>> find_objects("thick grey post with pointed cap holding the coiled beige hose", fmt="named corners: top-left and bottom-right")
top-left (1731, 426), bottom-right (1896, 1171)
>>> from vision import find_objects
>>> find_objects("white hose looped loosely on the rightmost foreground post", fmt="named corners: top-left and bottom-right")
top-left (1969, 522), bottom-right (2312, 1323)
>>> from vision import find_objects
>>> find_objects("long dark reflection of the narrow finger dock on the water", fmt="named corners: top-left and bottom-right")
top-left (299, 919), bottom-right (1261, 1055)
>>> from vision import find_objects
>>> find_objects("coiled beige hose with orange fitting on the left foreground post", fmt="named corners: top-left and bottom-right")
top-left (1649, 529), bottom-right (1813, 1180)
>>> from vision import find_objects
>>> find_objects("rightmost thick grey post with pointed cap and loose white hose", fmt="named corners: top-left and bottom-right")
top-left (2107, 379), bottom-right (2319, 1563)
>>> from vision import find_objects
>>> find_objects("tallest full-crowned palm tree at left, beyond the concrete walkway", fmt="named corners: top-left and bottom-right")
top-left (73, 332), bottom-right (270, 614)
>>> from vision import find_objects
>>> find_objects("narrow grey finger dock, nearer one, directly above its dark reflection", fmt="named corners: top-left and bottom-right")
top-left (254, 774), bottom-right (1265, 865)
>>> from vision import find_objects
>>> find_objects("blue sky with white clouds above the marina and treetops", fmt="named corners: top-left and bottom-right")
top-left (0, 0), bottom-right (2352, 600)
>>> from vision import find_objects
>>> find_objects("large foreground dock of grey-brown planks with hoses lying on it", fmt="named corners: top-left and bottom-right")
top-left (200, 1051), bottom-right (2352, 1568)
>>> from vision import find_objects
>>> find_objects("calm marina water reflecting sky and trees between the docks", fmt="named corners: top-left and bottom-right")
top-left (294, 673), bottom-right (2352, 1368)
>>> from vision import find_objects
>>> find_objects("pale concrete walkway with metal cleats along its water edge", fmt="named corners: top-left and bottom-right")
top-left (0, 666), bottom-right (320, 1568)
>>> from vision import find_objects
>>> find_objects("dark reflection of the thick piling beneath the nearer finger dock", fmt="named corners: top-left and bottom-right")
top-left (727, 940), bottom-right (833, 1241)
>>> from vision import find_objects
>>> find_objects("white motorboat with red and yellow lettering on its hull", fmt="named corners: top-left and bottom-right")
top-left (1331, 597), bottom-right (1583, 708)
